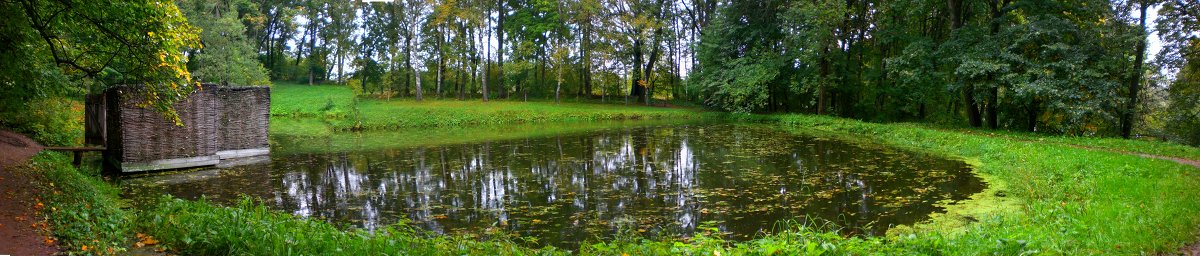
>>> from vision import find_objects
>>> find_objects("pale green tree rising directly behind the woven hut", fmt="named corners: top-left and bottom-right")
top-left (176, 0), bottom-right (270, 85)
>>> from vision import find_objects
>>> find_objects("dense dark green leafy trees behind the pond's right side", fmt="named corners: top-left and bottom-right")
top-left (688, 0), bottom-right (1176, 136)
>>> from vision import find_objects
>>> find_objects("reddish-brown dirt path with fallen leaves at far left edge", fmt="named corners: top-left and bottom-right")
top-left (0, 130), bottom-right (59, 255)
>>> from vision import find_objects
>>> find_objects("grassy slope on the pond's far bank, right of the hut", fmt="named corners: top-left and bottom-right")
top-left (271, 84), bottom-right (700, 131)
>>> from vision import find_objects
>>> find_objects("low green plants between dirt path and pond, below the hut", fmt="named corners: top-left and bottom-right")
top-left (29, 153), bottom-right (133, 255)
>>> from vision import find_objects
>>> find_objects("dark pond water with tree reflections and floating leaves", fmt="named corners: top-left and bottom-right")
top-left (122, 124), bottom-right (984, 248)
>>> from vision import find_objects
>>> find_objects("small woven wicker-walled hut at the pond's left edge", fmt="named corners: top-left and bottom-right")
top-left (84, 84), bottom-right (270, 172)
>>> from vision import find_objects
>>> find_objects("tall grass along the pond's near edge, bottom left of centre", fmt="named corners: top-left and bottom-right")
top-left (138, 197), bottom-right (564, 255)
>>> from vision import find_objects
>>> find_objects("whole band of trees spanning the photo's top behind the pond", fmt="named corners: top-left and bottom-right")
top-left (0, 0), bottom-right (1200, 144)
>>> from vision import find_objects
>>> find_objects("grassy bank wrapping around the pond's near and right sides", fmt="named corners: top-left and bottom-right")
top-left (16, 112), bottom-right (1200, 255)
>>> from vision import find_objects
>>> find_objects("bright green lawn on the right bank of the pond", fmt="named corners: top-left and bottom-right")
top-left (778, 115), bottom-right (1200, 255)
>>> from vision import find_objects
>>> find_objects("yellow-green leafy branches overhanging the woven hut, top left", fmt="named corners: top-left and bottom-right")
top-left (0, 0), bottom-right (198, 126)
